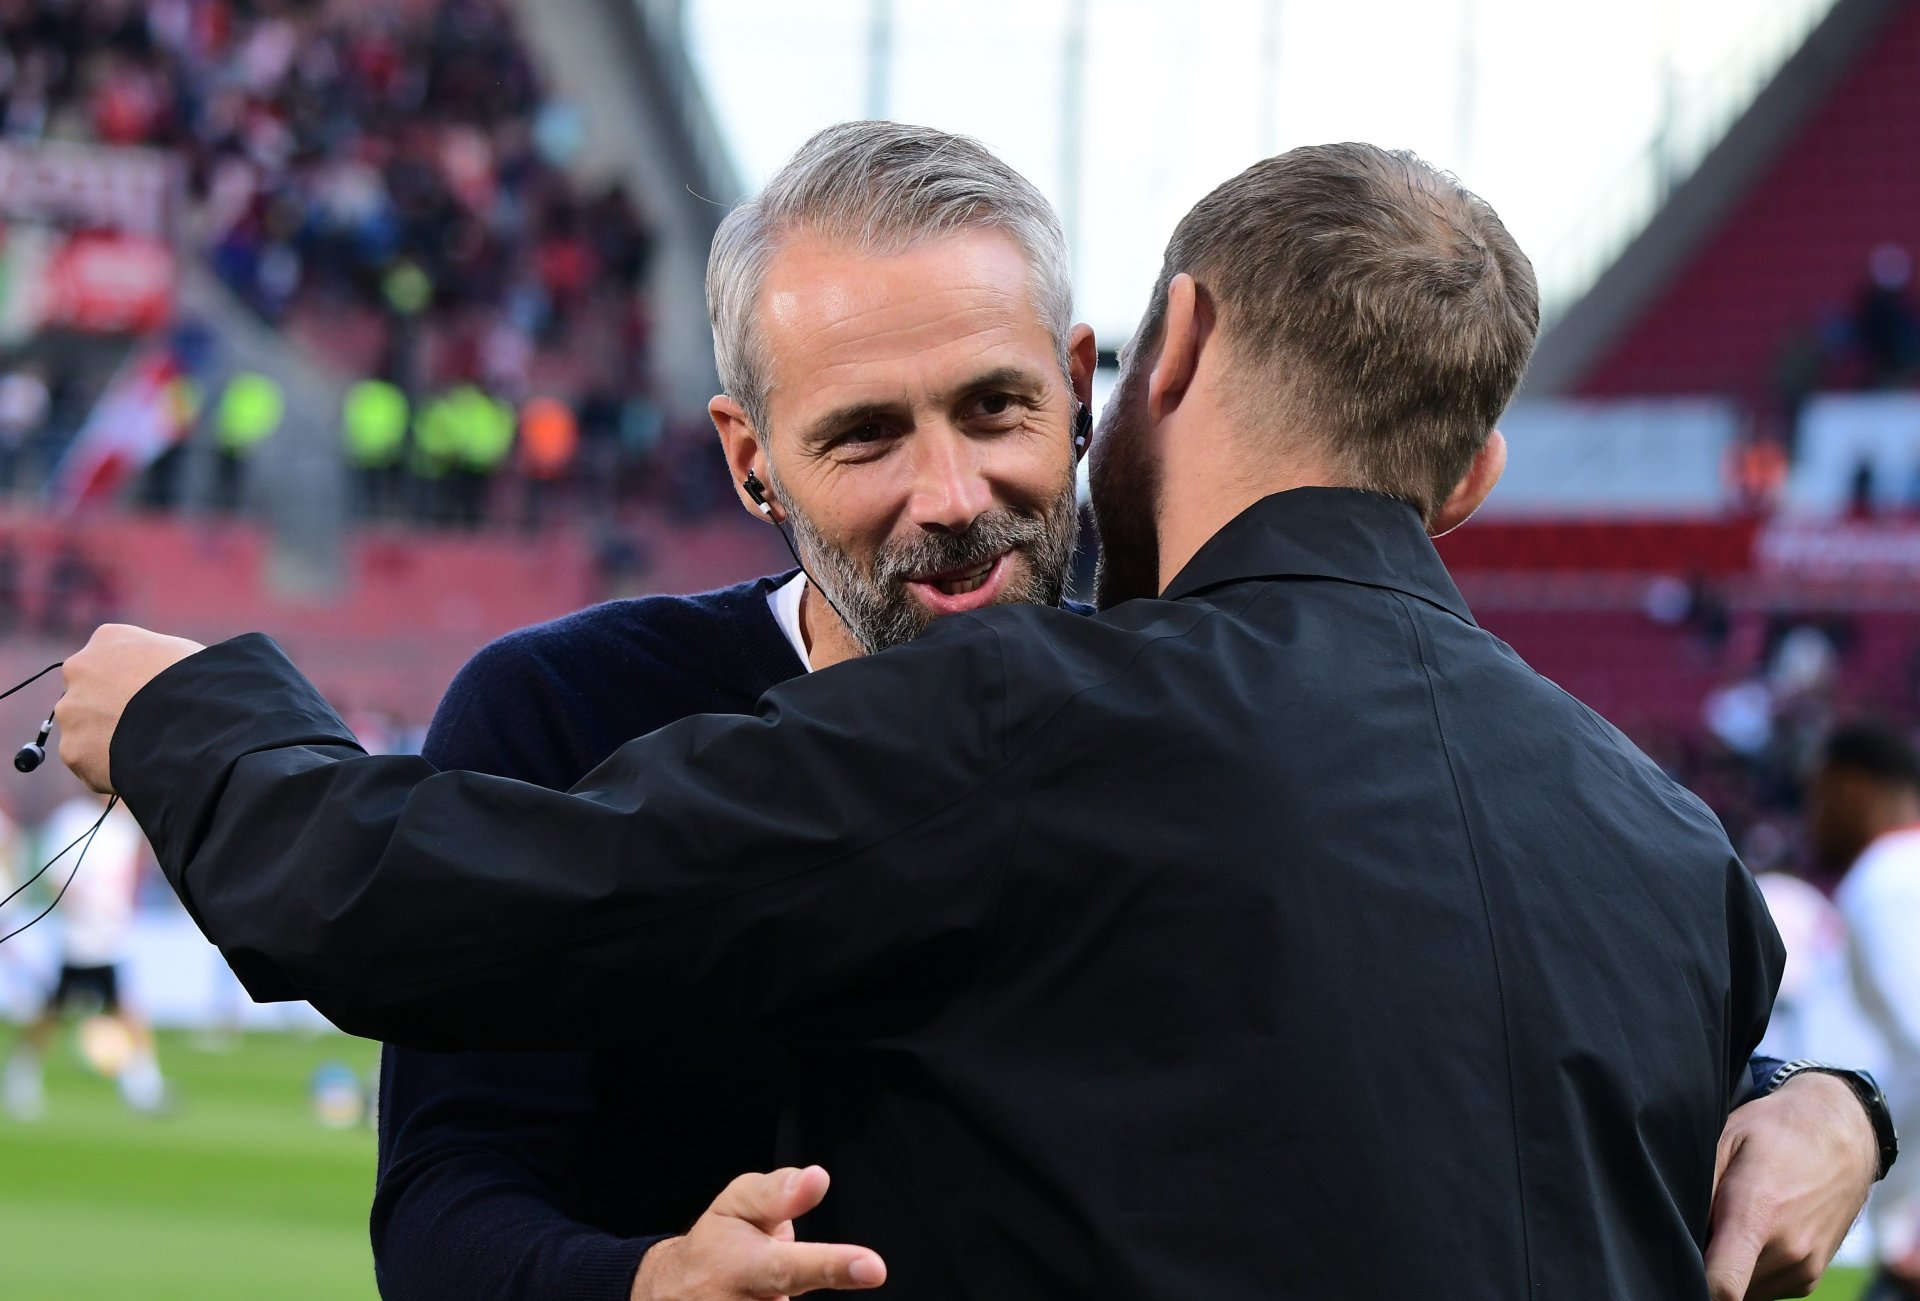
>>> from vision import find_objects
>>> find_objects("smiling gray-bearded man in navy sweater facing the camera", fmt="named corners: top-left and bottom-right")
top-left (360, 127), bottom-right (1092, 1301)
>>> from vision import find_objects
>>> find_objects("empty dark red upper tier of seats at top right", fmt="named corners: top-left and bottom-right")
top-left (1528, 0), bottom-right (1920, 405)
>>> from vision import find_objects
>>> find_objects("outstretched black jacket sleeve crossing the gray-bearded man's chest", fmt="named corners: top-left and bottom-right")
top-left (111, 633), bottom-right (1021, 1048)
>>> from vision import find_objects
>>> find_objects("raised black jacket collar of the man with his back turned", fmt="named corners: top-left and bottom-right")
top-left (1164, 487), bottom-right (1473, 624)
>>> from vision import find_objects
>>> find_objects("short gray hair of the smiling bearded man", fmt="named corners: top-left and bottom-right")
top-left (707, 123), bottom-right (1073, 439)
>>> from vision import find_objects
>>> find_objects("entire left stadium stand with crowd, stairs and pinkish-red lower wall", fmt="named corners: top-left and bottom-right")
top-left (0, 0), bottom-right (781, 812)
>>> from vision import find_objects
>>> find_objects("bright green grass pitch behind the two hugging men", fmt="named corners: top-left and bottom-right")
top-left (0, 1029), bottom-right (1862, 1301)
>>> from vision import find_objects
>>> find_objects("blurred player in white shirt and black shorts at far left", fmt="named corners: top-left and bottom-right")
top-left (0, 794), bottom-right (167, 1121)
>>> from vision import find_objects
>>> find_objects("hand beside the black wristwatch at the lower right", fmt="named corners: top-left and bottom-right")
top-left (1707, 1075), bottom-right (1880, 1301)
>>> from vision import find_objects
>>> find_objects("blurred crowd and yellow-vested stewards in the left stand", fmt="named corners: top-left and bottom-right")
top-left (0, 0), bottom-right (705, 526)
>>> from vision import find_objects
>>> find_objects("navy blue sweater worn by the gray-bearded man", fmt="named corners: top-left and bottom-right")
top-left (372, 574), bottom-right (804, 1301)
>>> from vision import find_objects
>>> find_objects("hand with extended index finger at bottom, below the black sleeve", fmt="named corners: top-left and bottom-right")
top-left (632, 1165), bottom-right (887, 1301)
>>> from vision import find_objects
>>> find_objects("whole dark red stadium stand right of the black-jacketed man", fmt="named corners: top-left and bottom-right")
top-left (1442, 0), bottom-right (1920, 886)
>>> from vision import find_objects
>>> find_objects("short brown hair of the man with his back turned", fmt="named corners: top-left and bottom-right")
top-left (1140, 144), bottom-right (1540, 516)
